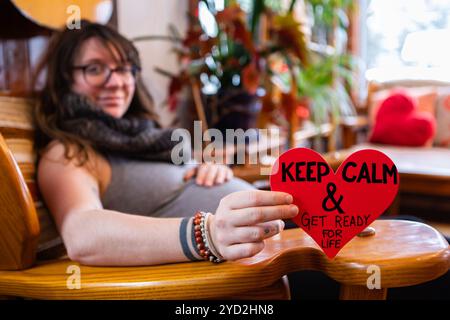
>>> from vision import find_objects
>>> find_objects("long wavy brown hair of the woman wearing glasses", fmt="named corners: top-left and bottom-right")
top-left (34, 20), bottom-right (158, 165)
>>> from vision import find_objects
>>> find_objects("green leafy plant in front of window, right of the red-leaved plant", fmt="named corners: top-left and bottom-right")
top-left (258, 0), bottom-right (355, 147)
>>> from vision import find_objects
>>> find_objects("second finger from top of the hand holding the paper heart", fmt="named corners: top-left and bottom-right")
top-left (229, 204), bottom-right (298, 227)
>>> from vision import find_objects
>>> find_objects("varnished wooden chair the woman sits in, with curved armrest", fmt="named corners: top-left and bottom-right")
top-left (0, 97), bottom-right (450, 299)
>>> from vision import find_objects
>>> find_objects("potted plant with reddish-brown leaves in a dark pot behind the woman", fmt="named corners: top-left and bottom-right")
top-left (159, 0), bottom-right (307, 140)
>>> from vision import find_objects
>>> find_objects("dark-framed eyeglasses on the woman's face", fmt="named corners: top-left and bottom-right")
top-left (73, 63), bottom-right (140, 87)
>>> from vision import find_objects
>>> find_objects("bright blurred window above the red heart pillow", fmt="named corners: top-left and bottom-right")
top-left (361, 0), bottom-right (450, 81)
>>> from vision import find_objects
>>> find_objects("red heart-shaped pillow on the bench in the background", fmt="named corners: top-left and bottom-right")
top-left (369, 92), bottom-right (436, 146)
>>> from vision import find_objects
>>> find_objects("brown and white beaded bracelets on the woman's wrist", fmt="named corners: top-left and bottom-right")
top-left (194, 211), bottom-right (224, 263)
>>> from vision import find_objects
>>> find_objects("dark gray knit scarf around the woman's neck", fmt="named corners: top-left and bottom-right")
top-left (61, 93), bottom-right (182, 162)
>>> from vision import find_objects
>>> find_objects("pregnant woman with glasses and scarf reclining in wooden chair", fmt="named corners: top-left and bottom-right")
top-left (35, 22), bottom-right (298, 266)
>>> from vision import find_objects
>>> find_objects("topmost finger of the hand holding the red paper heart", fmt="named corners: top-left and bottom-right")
top-left (220, 190), bottom-right (293, 210)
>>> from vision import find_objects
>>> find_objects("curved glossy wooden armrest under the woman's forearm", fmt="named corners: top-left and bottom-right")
top-left (0, 220), bottom-right (450, 299)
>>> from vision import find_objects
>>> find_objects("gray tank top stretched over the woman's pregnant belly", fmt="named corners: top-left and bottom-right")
top-left (100, 154), bottom-right (254, 218)
